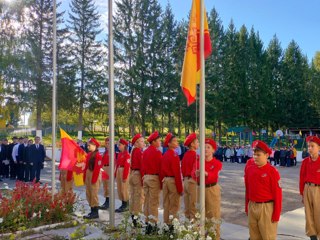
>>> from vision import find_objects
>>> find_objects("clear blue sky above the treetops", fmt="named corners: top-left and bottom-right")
top-left (61, 0), bottom-right (320, 60)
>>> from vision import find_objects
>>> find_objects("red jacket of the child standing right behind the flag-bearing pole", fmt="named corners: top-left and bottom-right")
top-left (191, 158), bottom-right (222, 185)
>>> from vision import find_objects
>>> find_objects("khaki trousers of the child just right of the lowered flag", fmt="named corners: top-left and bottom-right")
top-left (85, 169), bottom-right (101, 207)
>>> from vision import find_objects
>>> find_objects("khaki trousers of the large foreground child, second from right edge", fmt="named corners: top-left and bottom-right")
top-left (248, 202), bottom-right (278, 240)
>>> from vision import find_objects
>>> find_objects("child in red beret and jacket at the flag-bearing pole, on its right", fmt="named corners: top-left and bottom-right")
top-left (192, 138), bottom-right (222, 240)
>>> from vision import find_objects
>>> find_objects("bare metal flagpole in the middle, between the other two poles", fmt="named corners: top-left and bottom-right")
top-left (108, 0), bottom-right (115, 227)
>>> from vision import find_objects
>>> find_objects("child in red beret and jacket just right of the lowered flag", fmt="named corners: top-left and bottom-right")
top-left (83, 138), bottom-right (102, 219)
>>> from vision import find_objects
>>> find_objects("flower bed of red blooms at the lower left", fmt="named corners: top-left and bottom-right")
top-left (0, 181), bottom-right (75, 233)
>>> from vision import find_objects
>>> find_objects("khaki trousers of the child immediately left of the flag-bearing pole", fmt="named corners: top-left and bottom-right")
top-left (183, 178), bottom-right (197, 220)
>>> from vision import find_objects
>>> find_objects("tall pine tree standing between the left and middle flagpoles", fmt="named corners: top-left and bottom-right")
top-left (68, 0), bottom-right (103, 135)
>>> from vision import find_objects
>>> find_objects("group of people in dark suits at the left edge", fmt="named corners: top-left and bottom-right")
top-left (0, 137), bottom-right (46, 183)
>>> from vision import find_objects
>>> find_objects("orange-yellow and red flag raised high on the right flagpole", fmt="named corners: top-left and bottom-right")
top-left (181, 0), bottom-right (212, 106)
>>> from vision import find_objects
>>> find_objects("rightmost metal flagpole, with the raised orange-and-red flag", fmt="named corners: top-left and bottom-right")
top-left (199, 0), bottom-right (206, 239)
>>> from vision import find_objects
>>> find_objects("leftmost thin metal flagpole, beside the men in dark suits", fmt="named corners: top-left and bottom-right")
top-left (51, 0), bottom-right (57, 200)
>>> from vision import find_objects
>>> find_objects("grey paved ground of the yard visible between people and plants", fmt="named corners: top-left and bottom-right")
top-left (0, 162), bottom-right (307, 240)
